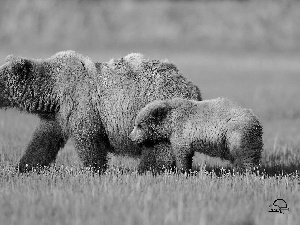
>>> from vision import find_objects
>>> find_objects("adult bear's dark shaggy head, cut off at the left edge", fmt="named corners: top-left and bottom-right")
top-left (0, 55), bottom-right (56, 114)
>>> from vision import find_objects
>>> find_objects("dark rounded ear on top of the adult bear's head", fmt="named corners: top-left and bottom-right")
top-left (10, 57), bottom-right (33, 80)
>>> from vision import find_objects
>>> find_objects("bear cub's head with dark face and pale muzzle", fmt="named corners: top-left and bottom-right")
top-left (129, 100), bottom-right (172, 145)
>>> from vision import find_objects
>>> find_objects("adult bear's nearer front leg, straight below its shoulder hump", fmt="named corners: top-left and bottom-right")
top-left (72, 115), bottom-right (110, 173)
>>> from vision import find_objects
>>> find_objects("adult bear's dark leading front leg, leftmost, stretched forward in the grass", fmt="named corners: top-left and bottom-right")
top-left (17, 117), bottom-right (67, 173)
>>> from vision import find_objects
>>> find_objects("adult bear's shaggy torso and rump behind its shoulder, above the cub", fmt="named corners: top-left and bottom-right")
top-left (96, 53), bottom-right (201, 155)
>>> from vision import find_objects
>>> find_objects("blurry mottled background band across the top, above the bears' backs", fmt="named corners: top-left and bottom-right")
top-left (0, 0), bottom-right (300, 50)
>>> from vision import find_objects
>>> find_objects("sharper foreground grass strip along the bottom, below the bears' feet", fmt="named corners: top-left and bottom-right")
top-left (0, 165), bottom-right (300, 225)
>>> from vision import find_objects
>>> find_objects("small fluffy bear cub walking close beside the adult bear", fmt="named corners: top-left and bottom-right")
top-left (130, 98), bottom-right (263, 171)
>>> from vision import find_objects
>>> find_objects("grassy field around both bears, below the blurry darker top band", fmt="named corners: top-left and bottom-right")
top-left (0, 50), bottom-right (300, 225)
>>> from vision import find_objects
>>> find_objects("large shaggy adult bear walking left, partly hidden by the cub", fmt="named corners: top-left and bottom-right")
top-left (0, 51), bottom-right (201, 172)
